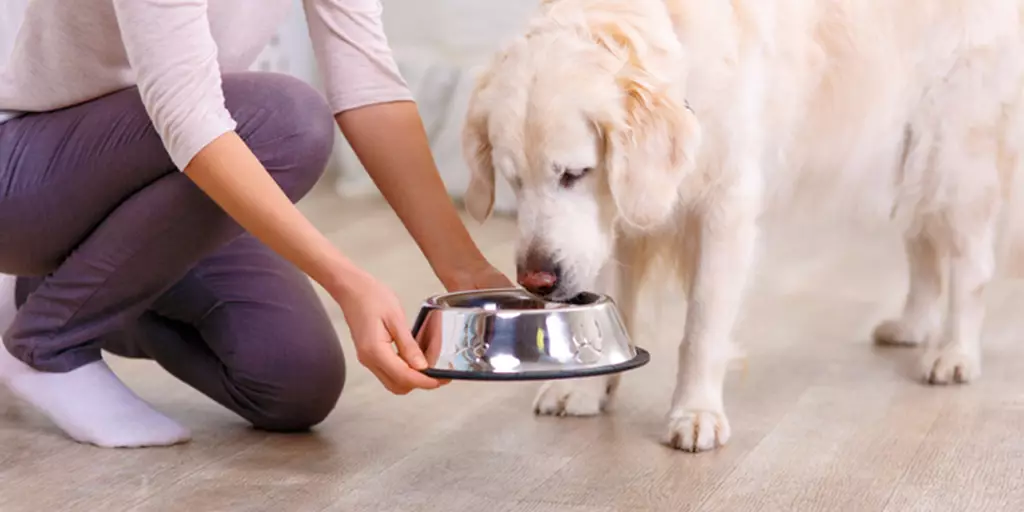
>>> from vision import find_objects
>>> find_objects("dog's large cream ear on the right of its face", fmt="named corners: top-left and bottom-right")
top-left (592, 20), bottom-right (700, 229)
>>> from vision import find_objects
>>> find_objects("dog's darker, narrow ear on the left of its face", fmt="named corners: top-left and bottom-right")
top-left (462, 106), bottom-right (495, 223)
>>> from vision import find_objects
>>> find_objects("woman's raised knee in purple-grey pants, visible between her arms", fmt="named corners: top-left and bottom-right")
top-left (223, 72), bottom-right (337, 201)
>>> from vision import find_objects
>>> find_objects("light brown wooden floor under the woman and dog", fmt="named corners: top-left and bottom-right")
top-left (0, 185), bottom-right (1024, 512)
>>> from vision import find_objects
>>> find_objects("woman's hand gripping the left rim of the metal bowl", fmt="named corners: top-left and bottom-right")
top-left (332, 270), bottom-right (446, 394)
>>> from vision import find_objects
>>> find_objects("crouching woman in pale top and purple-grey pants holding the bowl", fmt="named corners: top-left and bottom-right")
top-left (0, 0), bottom-right (509, 446)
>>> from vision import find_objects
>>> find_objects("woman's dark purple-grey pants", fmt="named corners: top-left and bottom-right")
top-left (0, 73), bottom-right (345, 430)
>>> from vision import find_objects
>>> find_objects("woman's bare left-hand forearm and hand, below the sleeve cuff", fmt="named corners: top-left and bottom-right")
top-left (184, 132), bottom-right (441, 394)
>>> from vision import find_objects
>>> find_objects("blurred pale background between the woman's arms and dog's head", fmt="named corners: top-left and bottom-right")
top-left (254, 0), bottom-right (539, 213)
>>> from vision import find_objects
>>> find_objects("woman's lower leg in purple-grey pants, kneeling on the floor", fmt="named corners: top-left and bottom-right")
top-left (82, 234), bottom-right (345, 431)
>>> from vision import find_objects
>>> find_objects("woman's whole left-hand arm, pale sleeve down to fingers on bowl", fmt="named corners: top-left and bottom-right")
top-left (114, 0), bottom-right (440, 393)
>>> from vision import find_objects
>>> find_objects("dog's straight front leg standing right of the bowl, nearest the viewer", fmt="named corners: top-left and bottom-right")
top-left (666, 191), bottom-right (759, 452)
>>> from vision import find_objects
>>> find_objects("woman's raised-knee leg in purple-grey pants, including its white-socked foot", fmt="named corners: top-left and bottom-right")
top-left (0, 74), bottom-right (334, 445)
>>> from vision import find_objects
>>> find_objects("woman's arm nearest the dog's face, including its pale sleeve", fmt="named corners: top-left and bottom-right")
top-left (304, 0), bottom-right (511, 290)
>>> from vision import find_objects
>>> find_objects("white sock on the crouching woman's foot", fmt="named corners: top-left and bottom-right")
top-left (0, 275), bottom-right (191, 447)
